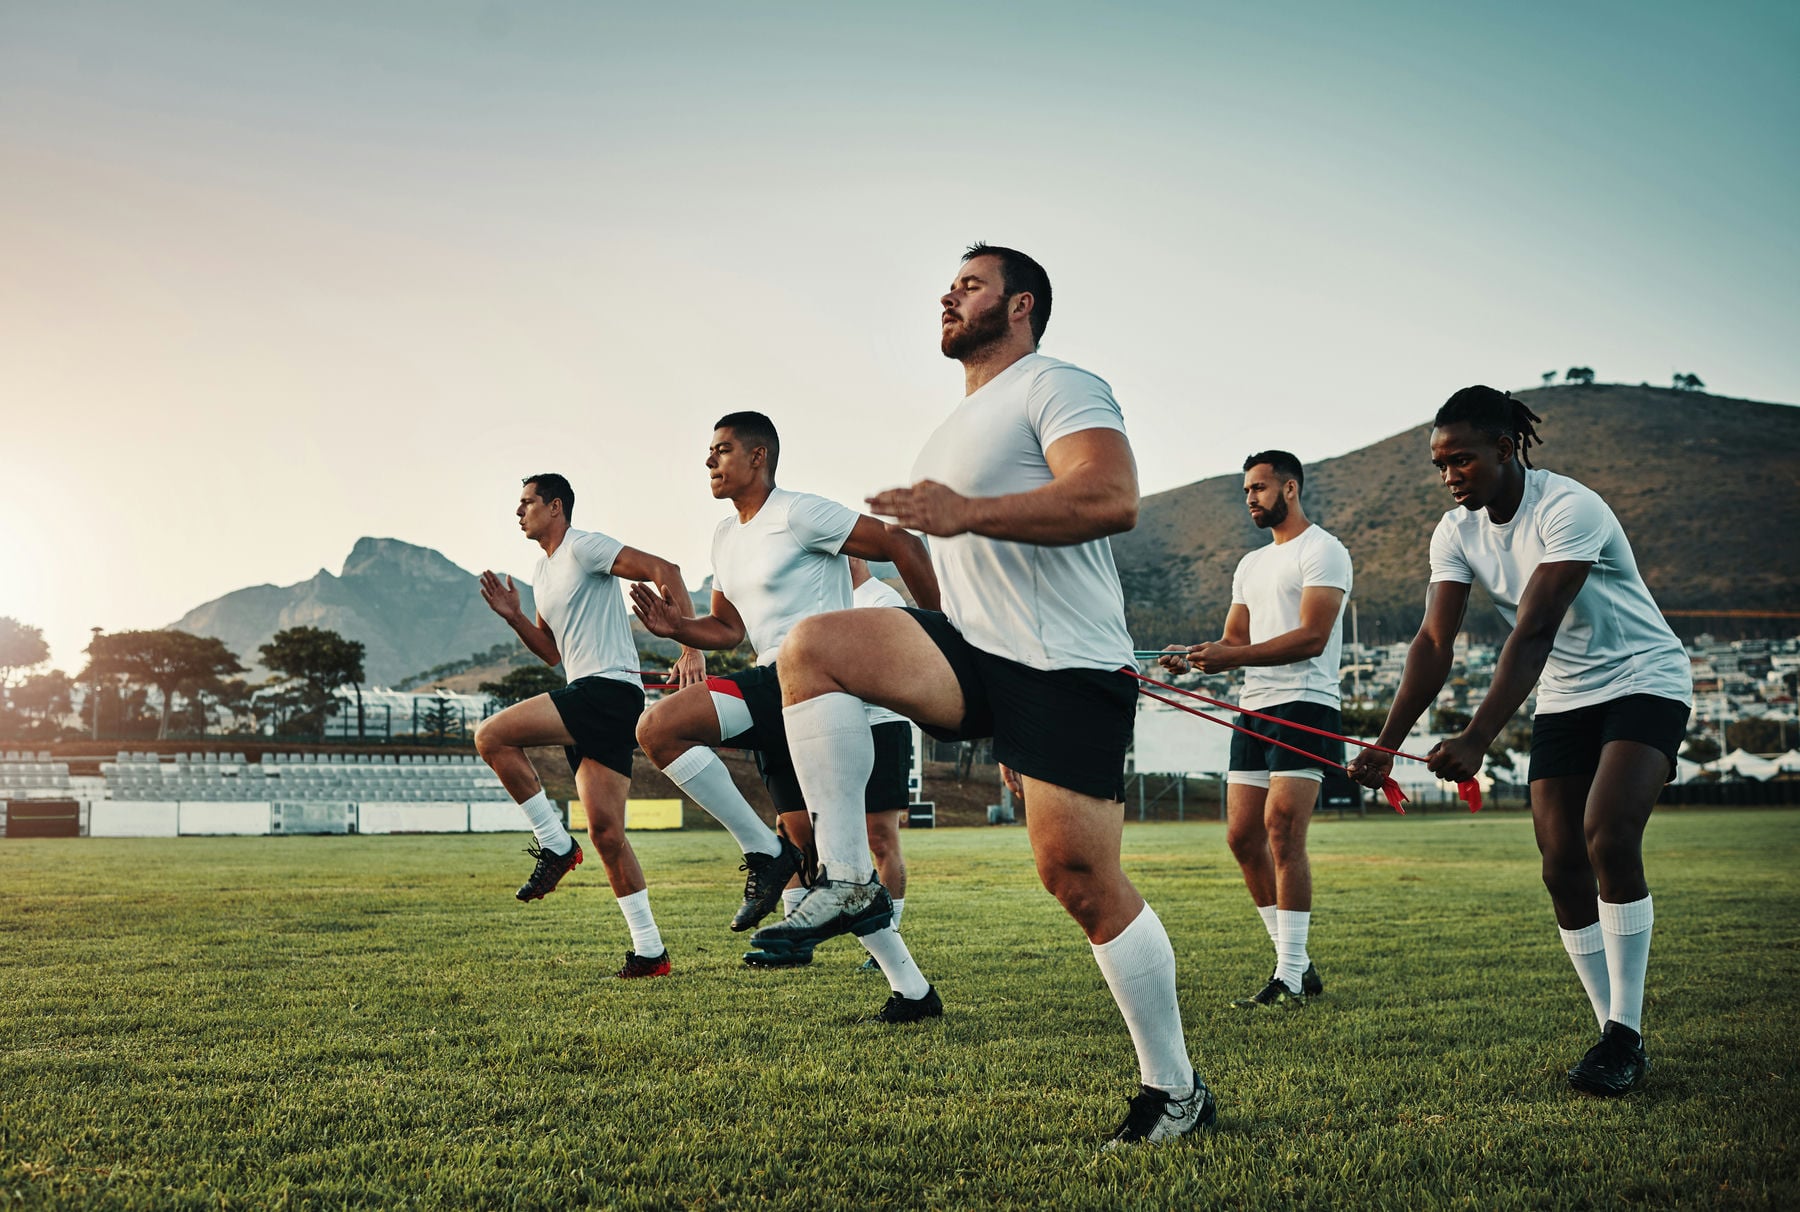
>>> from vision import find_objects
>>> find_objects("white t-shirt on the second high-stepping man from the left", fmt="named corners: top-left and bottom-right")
top-left (713, 488), bottom-right (860, 665)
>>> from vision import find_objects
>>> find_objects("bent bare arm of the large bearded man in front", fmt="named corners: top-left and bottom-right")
top-left (869, 429), bottom-right (1138, 547)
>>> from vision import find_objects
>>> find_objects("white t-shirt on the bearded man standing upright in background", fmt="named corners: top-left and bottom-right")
top-left (1231, 526), bottom-right (1352, 710)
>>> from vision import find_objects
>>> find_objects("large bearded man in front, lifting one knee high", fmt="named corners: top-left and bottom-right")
top-left (738, 245), bottom-right (1215, 1145)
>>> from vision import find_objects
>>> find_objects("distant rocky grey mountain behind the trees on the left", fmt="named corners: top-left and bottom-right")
top-left (173, 538), bottom-right (533, 686)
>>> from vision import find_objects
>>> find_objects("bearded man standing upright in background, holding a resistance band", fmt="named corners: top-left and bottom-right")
top-left (1163, 450), bottom-right (1352, 1010)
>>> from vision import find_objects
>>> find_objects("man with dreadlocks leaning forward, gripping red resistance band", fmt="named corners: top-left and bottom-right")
top-left (1350, 387), bottom-right (1694, 1095)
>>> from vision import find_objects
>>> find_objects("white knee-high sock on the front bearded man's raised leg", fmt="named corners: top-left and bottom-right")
top-left (781, 692), bottom-right (875, 884)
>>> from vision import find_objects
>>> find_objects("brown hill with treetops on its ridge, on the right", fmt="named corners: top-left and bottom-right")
top-left (1112, 384), bottom-right (1800, 647)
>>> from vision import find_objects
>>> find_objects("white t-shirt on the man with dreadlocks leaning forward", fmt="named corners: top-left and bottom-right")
top-left (1431, 470), bottom-right (1694, 711)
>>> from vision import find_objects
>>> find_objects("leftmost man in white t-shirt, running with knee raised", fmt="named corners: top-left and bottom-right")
top-left (475, 472), bottom-right (706, 980)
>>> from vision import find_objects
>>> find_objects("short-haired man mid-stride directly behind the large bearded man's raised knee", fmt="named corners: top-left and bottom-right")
top-left (632, 412), bottom-right (943, 1023)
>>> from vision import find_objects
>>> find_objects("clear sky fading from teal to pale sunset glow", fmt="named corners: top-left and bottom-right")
top-left (0, 0), bottom-right (1800, 674)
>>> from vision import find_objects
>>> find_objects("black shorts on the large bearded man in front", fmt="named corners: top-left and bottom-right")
top-left (905, 607), bottom-right (1138, 800)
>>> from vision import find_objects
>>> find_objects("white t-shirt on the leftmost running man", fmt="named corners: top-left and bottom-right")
top-left (531, 528), bottom-right (644, 686)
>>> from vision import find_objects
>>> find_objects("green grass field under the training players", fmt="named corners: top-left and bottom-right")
top-left (0, 812), bottom-right (1800, 1210)
